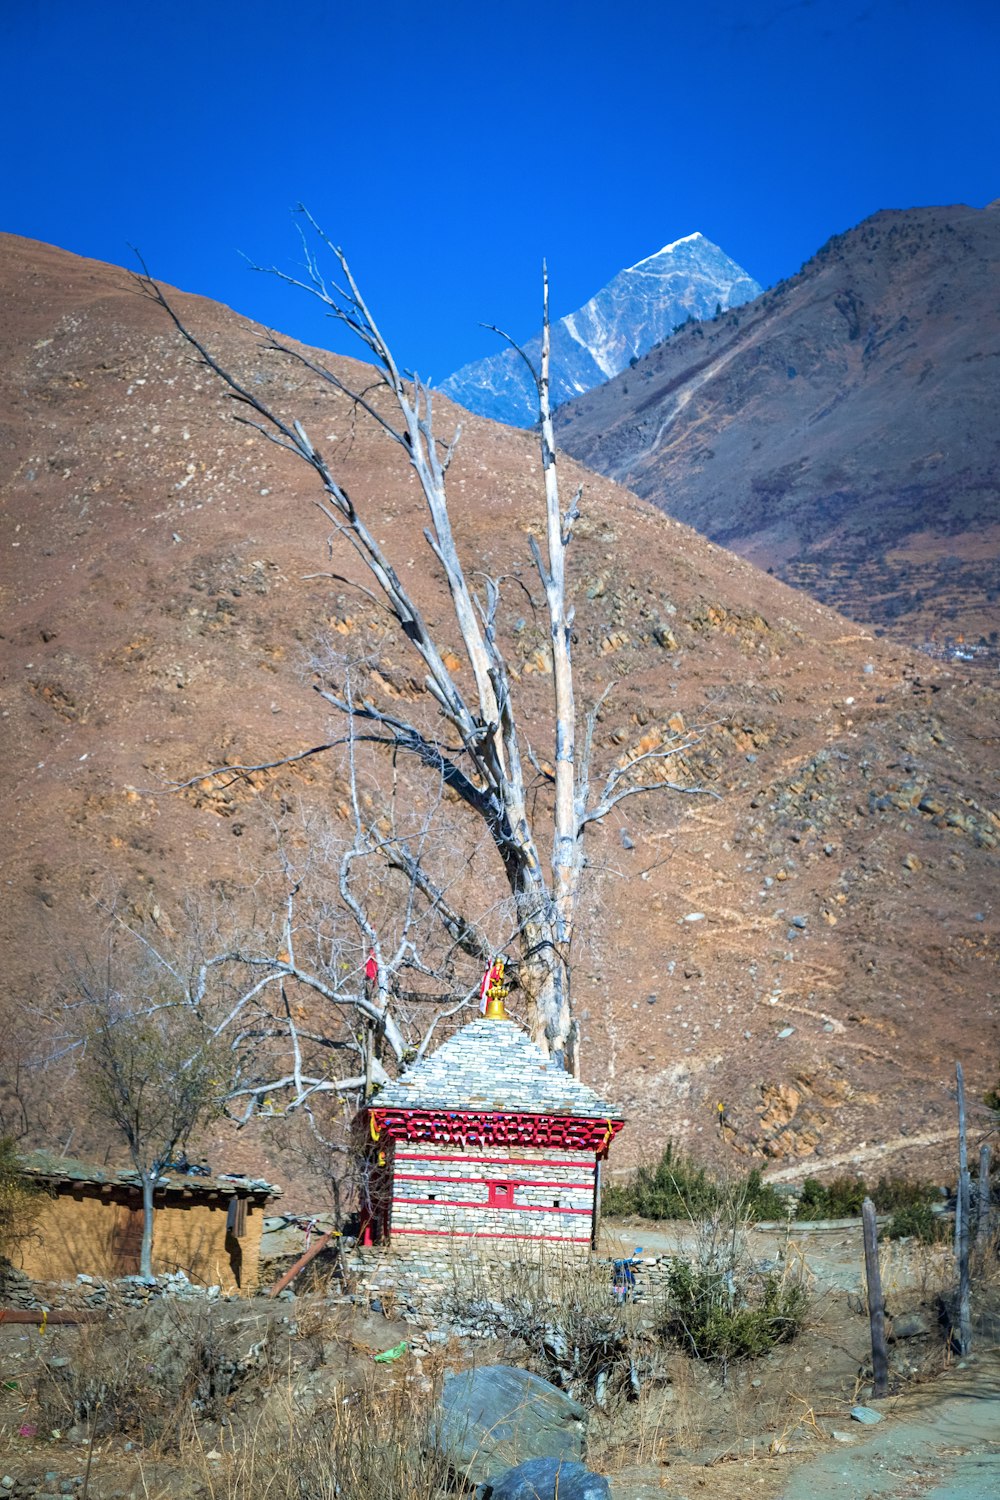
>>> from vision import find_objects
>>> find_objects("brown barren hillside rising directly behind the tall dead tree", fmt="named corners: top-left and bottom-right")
top-left (0, 237), bottom-right (1000, 1206)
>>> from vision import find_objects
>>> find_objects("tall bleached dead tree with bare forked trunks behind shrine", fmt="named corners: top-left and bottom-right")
top-left (141, 210), bottom-right (707, 1071)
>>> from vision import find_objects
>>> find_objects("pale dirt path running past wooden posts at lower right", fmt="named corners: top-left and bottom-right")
top-left (603, 1220), bottom-right (1000, 1500)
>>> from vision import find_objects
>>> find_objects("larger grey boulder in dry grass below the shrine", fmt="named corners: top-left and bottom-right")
top-left (435, 1365), bottom-right (586, 1485)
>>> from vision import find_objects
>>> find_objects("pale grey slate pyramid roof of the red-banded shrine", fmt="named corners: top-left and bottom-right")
top-left (372, 1017), bottom-right (621, 1119)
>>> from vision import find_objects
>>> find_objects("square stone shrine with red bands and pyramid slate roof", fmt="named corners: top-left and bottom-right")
top-left (361, 1005), bottom-right (624, 1254)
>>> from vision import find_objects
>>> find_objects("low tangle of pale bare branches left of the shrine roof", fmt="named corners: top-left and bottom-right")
top-left (105, 738), bottom-right (516, 1151)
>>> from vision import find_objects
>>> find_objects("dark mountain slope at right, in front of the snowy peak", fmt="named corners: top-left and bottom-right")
top-left (558, 204), bottom-right (1000, 657)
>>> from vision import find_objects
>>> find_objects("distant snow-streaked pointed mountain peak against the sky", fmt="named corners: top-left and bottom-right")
top-left (441, 234), bottom-right (760, 428)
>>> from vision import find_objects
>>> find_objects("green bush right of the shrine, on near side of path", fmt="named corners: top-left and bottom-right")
top-left (660, 1259), bottom-right (808, 1365)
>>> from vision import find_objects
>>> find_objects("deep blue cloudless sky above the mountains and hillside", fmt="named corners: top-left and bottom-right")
top-left (0, 0), bottom-right (1000, 380)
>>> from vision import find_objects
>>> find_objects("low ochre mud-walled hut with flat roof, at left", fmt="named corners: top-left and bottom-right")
top-left (19, 1151), bottom-right (280, 1296)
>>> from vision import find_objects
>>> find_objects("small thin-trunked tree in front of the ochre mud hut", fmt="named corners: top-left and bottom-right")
top-left (82, 992), bottom-right (223, 1277)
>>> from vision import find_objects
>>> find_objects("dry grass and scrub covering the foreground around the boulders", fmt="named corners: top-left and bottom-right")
top-left (9, 1223), bottom-right (1000, 1500)
